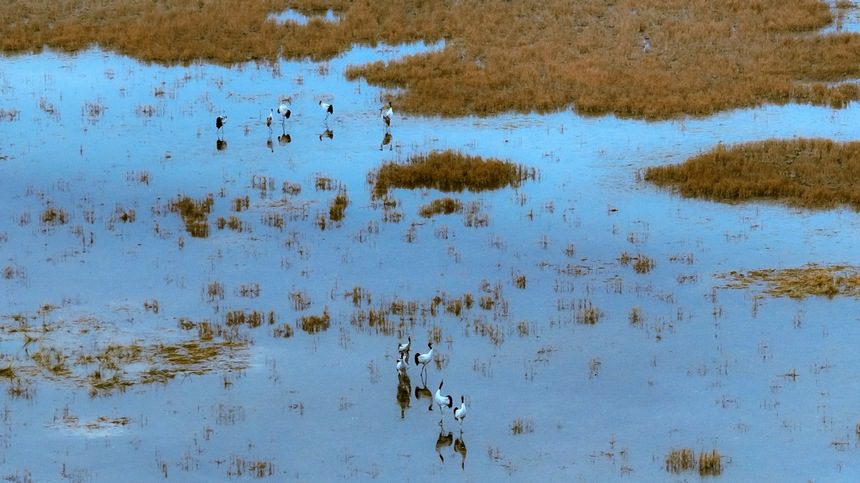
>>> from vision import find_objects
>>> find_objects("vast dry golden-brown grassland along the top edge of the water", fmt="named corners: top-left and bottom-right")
top-left (0, 0), bottom-right (860, 118)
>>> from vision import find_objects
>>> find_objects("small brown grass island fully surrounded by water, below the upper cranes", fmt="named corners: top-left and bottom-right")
top-left (373, 150), bottom-right (535, 198)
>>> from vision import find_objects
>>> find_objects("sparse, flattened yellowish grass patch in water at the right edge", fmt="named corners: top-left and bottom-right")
top-left (720, 265), bottom-right (860, 299)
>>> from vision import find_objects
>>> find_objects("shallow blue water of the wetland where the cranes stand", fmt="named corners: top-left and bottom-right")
top-left (0, 20), bottom-right (860, 481)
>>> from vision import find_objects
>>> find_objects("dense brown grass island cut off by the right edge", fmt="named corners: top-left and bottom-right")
top-left (645, 139), bottom-right (860, 210)
